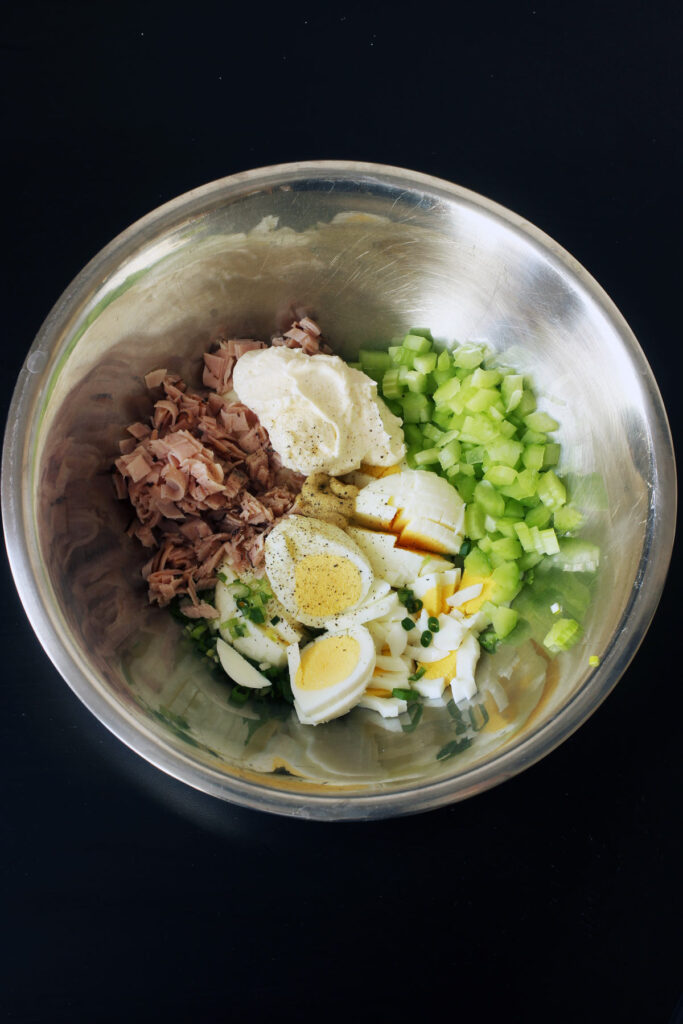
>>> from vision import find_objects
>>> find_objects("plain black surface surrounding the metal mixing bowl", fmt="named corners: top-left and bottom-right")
top-left (0, 0), bottom-right (683, 1024)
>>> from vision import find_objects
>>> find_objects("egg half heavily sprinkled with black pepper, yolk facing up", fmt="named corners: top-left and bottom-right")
top-left (265, 515), bottom-right (373, 628)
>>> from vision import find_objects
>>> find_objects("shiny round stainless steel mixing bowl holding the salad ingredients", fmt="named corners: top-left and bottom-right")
top-left (2, 162), bottom-right (675, 819)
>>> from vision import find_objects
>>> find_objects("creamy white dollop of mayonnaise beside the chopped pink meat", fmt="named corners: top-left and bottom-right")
top-left (232, 347), bottom-right (405, 476)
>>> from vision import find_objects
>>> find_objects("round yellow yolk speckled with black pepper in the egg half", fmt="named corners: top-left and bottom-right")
top-left (294, 555), bottom-right (362, 616)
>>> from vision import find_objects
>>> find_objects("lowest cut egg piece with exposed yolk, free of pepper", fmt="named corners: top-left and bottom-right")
top-left (289, 626), bottom-right (376, 725)
